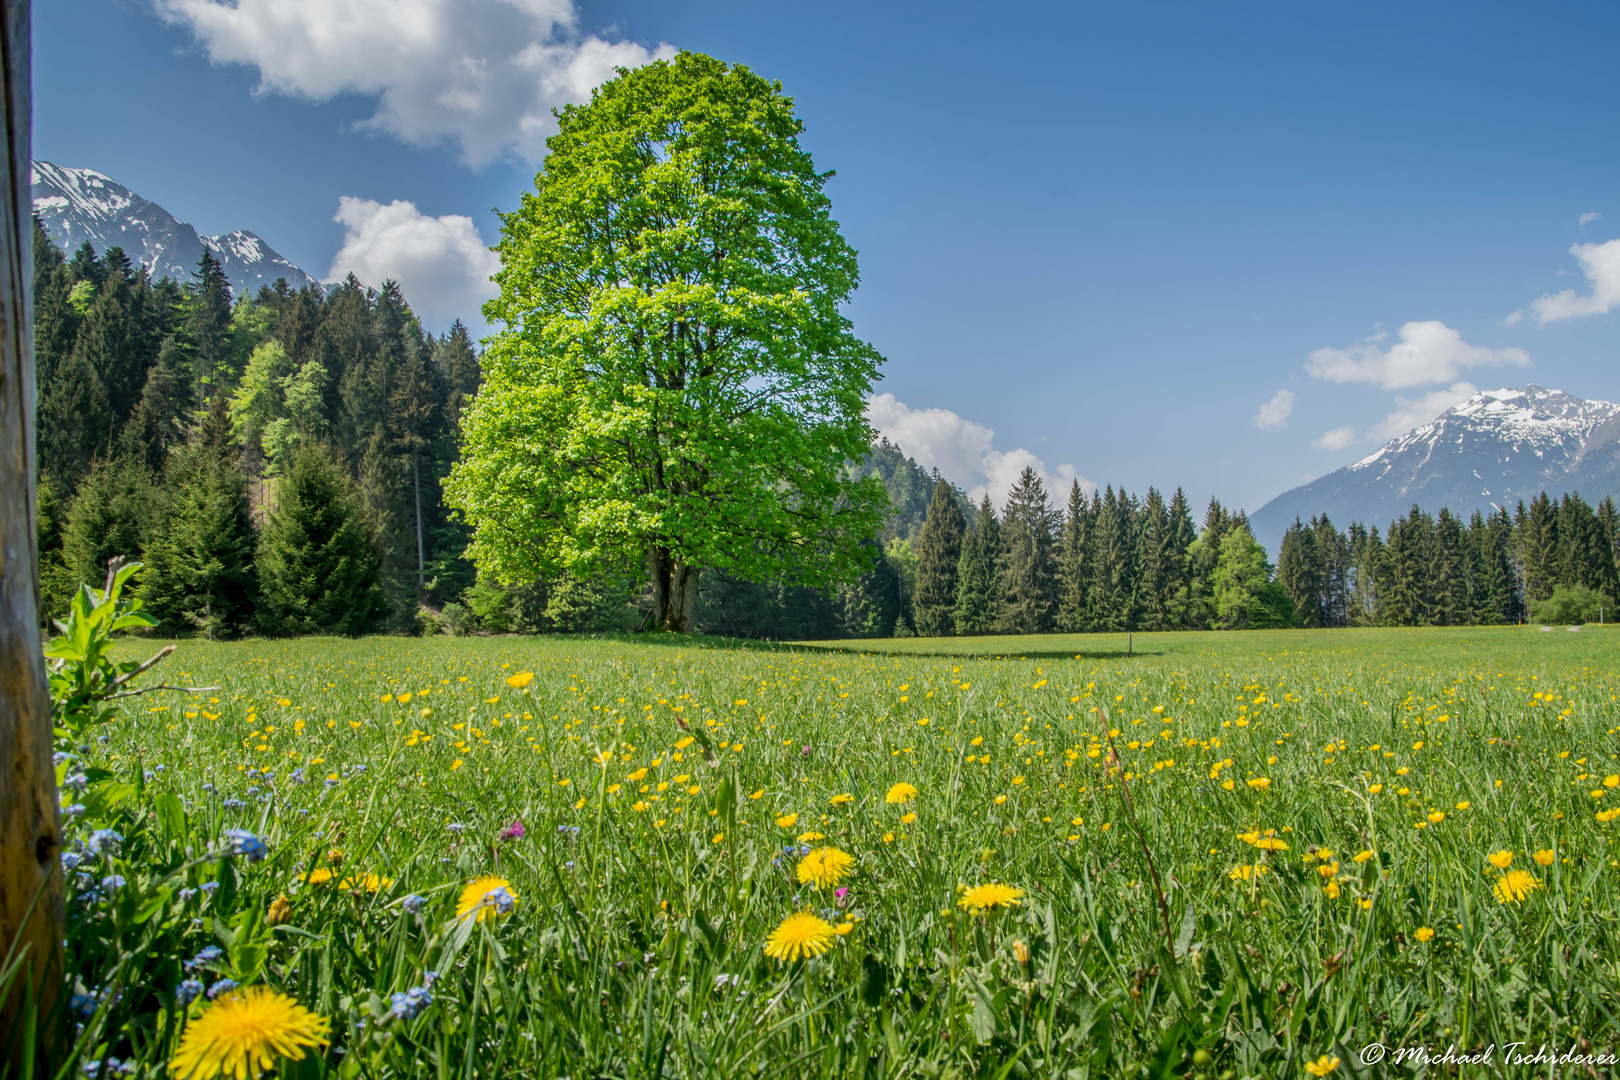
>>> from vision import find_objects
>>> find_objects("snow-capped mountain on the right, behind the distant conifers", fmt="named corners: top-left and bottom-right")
top-left (1249, 385), bottom-right (1620, 554)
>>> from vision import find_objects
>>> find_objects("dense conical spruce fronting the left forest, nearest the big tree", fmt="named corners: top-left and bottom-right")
top-left (256, 445), bottom-right (387, 636)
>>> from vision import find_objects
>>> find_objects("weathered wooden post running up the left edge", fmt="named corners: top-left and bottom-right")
top-left (0, 0), bottom-right (63, 1075)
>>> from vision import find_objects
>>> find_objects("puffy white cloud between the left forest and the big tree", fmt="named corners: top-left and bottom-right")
top-left (327, 194), bottom-right (501, 335)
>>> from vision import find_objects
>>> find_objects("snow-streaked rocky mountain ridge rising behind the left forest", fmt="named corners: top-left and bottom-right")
top-left (32, 162), bottom-right (321, 296)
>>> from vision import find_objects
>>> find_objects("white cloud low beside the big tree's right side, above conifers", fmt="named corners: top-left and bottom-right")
top-left (867, 393), bottom-right (1097, 505)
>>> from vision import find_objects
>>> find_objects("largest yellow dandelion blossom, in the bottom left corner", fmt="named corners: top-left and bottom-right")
top-left (168, 986), bottom-right (330, 1080)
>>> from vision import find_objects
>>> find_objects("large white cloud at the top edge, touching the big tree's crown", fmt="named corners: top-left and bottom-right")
top-left (152, 0), bottom-right (676, 167)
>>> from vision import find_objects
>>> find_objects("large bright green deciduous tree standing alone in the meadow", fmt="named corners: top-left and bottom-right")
top-left (449, 53), bottom-right (886, 631)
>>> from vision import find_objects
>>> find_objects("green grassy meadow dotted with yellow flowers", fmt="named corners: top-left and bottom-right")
top-left (65, 627), bottom-right (1620, 1080)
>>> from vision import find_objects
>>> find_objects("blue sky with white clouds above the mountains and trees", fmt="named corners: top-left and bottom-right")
top-left (34, 0), bottom-right (1620, 510)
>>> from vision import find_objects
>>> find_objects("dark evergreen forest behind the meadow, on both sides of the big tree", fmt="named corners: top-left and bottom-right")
top-left (34, 225), bottom-right (1620, 640)
